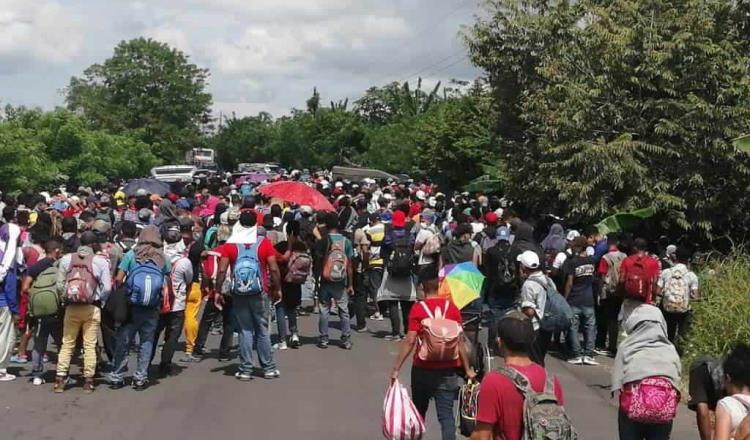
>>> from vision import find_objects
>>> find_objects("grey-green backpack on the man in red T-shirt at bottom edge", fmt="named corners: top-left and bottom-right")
top-left (500, 367), bottom-right (578, 440)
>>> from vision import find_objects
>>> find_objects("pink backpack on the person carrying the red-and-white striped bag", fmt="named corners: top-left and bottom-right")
top-left (417, 300), bottom-right (464, 362)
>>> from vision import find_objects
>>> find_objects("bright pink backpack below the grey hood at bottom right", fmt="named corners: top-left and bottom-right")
top-left (620, 376), bottom-right (680, 424)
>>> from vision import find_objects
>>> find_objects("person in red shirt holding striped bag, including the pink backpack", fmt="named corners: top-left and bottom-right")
top-left (391, 268), bottom-right (476, 440)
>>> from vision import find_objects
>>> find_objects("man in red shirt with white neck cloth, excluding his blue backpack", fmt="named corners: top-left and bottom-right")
top-left (214, 211), bottom-right (281, 381)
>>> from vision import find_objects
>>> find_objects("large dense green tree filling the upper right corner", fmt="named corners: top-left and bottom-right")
top-left (467, 0), bottom-right (750, 238)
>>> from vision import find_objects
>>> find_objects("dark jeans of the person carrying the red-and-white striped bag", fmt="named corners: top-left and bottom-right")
top-left (411, 367), bottom-right (458, 440)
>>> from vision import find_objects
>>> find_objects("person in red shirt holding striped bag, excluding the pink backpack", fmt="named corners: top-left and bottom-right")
top-left (391, 268), bottom-right (476, 440)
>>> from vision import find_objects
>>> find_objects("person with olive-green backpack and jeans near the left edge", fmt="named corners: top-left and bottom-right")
top-left (21, 240), bottom-right (62, 385)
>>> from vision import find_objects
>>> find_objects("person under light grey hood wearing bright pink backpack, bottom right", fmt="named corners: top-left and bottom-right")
top-left (611, 303), bottom-right (682, 440)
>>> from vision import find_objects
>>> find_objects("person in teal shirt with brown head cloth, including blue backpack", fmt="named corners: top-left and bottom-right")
top-left (109, 225), bottom-right (171, 391)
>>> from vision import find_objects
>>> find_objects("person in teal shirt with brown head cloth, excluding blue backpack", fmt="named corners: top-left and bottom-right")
top-left (109, 225), bottom-right (171, 391)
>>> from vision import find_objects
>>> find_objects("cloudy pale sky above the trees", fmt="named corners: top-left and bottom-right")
top-left (0, 0), bottom-right (479, 116)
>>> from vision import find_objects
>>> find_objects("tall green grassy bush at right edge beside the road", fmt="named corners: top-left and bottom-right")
top-left (683, 253), bottom-right (750, 373)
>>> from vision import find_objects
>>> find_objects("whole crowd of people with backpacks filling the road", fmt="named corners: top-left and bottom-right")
top-left (0, 169), bottom-right (750, 440)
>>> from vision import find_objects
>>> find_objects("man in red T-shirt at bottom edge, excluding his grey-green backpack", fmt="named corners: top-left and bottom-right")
top-left (471, 312), bottom-right (563, 440)
